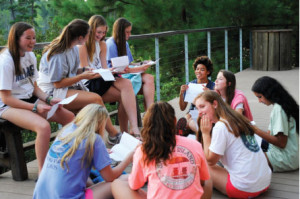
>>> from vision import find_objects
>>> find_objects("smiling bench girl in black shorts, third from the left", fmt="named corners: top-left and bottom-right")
top-left (79, 15), bottom-right (140, 138)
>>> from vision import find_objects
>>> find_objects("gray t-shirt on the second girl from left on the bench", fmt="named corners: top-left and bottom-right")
top-left (37, 46), bottom-right (80, 93)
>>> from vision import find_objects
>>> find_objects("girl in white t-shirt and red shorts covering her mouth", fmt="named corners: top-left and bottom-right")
top-left (195, 91), bottom-right (272, 198)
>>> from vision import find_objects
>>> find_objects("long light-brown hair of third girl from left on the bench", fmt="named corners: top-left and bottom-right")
top-left (85, 15), bottom-right (107, 62)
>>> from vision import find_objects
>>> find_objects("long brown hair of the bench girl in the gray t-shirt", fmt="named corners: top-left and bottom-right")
top-left (43, 19), bottom-right (90, 61)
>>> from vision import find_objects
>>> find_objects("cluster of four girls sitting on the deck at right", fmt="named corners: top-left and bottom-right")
top-left (177, 56), bottom-right (299, 198)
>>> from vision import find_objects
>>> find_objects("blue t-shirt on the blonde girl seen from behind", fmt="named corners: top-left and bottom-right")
top-left (33, 124), bottom-right (111, 199)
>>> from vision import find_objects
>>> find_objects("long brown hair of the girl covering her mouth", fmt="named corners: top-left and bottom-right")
top-left (194, 90), bottom-right (254, 140)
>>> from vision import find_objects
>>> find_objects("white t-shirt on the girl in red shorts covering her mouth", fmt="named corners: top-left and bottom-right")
top-left (209, 121), bottom-right (272, 192)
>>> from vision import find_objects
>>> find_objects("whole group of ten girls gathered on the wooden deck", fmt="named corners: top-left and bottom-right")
top-left (0, 16), bottom-right (299, 198)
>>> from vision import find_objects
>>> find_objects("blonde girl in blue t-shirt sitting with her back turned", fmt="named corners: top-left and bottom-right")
top-left (33, 104), bottom-right (133, 199)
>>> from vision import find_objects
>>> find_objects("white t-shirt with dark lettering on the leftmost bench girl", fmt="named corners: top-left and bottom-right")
top-left (0, 49), bottom-right (38, 107)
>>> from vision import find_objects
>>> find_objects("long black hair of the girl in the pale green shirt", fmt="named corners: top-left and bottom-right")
top-left (251, 76), bottom-right (299, 133)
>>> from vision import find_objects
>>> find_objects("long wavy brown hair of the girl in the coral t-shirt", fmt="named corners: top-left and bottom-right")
top-left (141, 102), bottom-right (176, 165)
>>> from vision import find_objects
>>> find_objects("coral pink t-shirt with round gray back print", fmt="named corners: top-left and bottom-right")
top-left (129, 136), bottom-right (210, 198)
